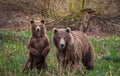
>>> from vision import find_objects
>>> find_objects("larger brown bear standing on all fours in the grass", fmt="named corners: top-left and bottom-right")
top-left (53, 27), bottom-right (94, 71)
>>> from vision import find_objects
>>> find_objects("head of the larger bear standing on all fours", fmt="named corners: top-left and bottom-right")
top-left (53, 27), bottom-right (71, 50)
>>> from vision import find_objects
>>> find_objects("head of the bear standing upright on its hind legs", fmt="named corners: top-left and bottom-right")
top-left (31, 20), bottom-right (46, 38)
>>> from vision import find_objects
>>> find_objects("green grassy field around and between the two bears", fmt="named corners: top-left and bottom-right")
top-left (0, 30), bottom-right (120, 76)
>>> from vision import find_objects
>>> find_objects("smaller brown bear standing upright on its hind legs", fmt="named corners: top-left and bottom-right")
top-left (23, 20), bottom-right (50, 72)
